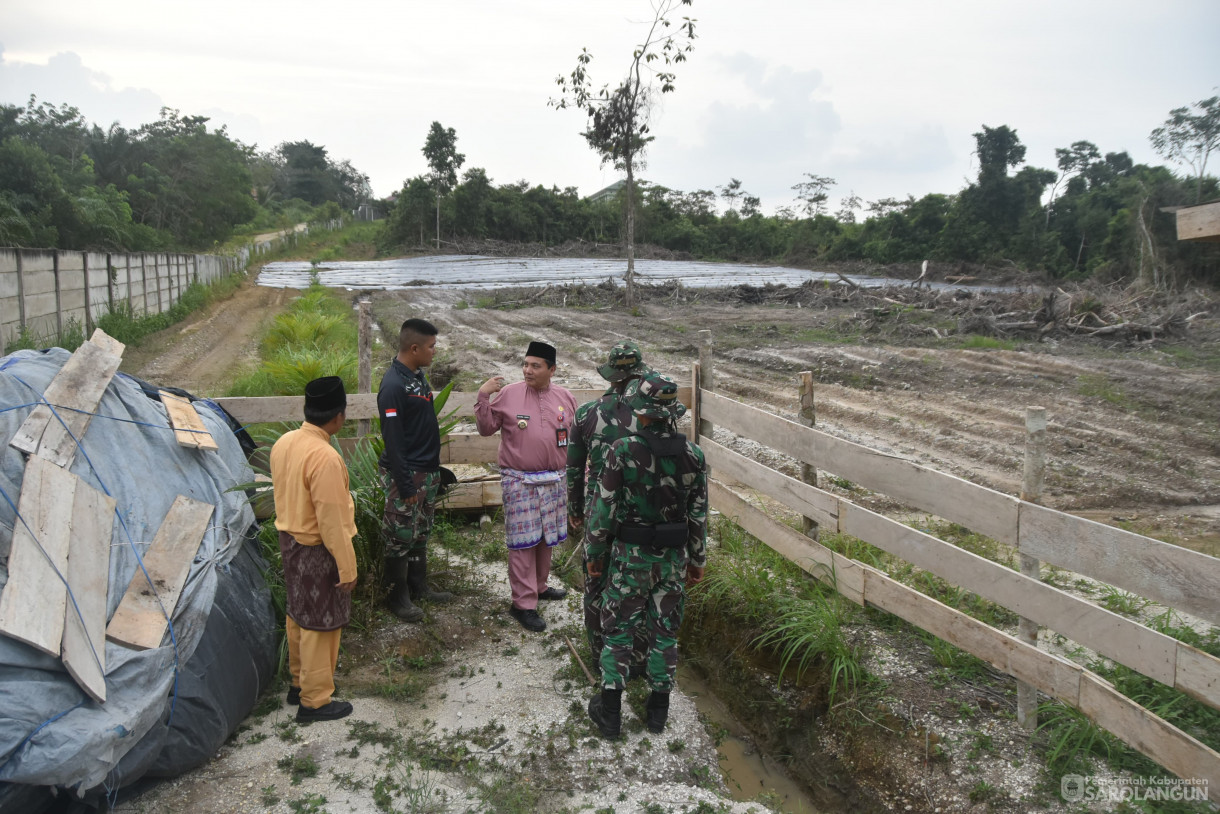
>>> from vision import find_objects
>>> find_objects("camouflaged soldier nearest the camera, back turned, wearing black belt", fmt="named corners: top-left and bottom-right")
top-left (584, 372), bottom-right (708, 738)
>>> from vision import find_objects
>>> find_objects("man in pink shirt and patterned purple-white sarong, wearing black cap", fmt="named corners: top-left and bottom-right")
top-left (475, 342), bottom-right (576, 632)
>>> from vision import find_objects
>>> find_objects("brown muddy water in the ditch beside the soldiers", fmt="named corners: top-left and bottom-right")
top-left (677, 664), bottom-right (826, 814)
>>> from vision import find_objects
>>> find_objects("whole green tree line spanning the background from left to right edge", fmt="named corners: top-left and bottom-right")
top-left (0, 94), bottom-right (1220, 287)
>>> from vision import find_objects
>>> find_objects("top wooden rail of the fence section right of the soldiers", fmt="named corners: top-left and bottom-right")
top-left (700, 391), bottom-right (1220, 625)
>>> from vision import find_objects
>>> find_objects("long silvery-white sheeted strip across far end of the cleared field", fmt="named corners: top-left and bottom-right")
top-left (257, 255), bottom-right (990, 290)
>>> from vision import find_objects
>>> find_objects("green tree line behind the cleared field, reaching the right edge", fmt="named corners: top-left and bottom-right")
top-left (387, 104), bottom-right (1220, 287)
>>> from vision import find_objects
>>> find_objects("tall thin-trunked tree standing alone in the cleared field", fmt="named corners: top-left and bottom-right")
top-left (548, 0), bottom-right (695, 306)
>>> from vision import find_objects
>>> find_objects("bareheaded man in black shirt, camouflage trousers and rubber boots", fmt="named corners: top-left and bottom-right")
top-left (377, 319), bottom-right (453, 622)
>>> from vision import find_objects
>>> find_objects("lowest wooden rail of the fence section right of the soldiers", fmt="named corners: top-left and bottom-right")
top-left (709, 480), bottom-right (1220, 788)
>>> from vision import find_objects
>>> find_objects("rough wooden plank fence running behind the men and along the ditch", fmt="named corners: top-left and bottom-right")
top-left (217, 370), bottom-right (1220, 788)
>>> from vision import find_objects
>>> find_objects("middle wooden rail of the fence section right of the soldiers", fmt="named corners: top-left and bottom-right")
top-left (703, 439), bottom-right (1220, 709)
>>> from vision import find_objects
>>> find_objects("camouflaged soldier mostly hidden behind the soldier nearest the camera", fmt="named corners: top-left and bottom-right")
top-left (567, 340), bottom-right (651, 677)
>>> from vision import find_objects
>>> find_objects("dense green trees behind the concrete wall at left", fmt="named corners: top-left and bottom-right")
top-left (0, 96), bottom-right (372, 251)
